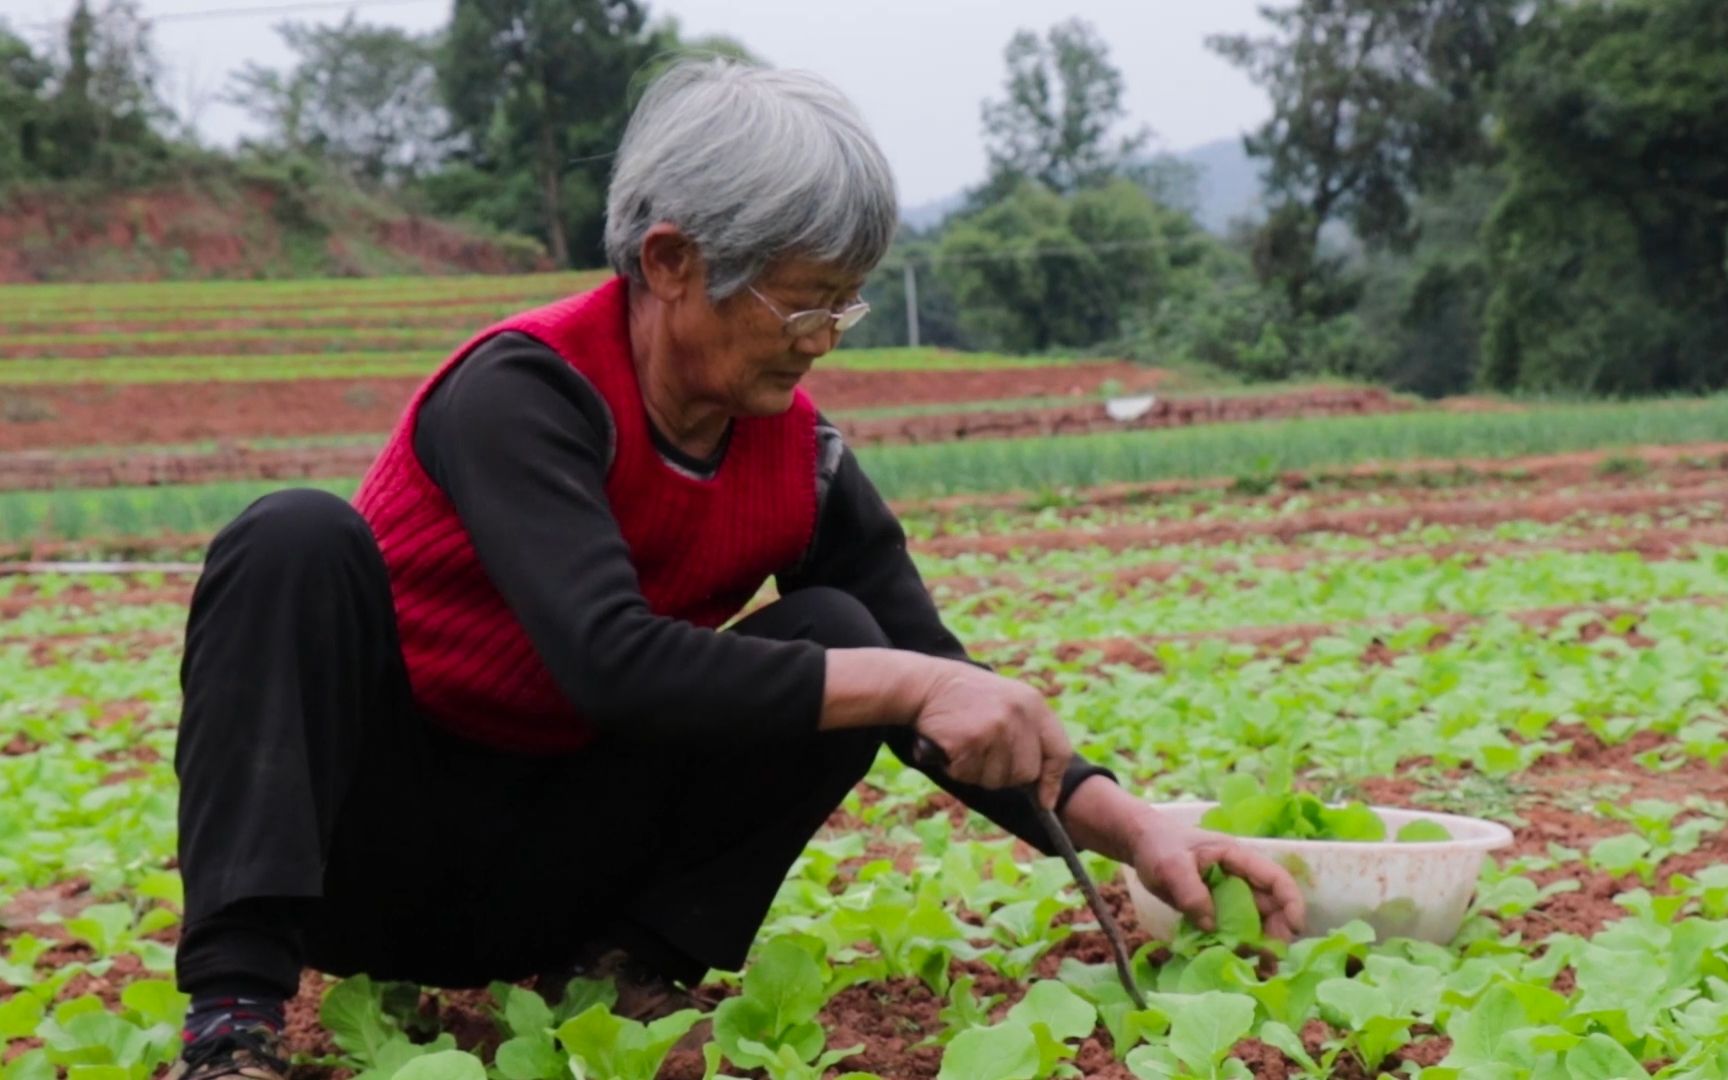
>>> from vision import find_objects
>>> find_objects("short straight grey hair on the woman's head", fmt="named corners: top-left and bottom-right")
top-left (607, 59), bottom-right (900, 301)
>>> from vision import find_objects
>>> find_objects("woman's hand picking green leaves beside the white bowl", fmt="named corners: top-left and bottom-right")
top-left (1132, 819), bottom-right (1306, 942)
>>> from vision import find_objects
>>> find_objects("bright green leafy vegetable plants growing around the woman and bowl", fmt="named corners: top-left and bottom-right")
top-left (0, 542), bottom-right (1728, 1080)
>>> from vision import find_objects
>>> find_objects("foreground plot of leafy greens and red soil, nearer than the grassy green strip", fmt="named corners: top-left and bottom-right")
top-left (0, 440), bottom-right (1728, 1080)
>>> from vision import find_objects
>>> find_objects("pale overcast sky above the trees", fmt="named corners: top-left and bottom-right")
top-left (0, 0), bottom-right (1270, 206)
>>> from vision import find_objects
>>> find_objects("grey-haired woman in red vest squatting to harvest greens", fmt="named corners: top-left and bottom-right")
top-left (165, 62), bottom-right (1301, 1080)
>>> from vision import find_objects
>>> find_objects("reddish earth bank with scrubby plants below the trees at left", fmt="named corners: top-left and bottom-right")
top-left (0, 173), bottom-right (551, 285)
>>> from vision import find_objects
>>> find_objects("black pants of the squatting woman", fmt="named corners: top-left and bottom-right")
top-left (175, 491), bottom-right (886, 992)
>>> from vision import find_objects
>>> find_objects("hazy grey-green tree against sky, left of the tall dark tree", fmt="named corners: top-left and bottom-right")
top-left (228, 14), bottom-right (449, 183)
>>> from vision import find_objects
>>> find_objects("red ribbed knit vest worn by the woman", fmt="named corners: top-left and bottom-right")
top-left (354, 278), bottom-right (816, 753)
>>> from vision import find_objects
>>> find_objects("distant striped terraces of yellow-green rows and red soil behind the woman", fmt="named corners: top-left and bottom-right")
top-left (0, 273), bottom-right (1188, 459)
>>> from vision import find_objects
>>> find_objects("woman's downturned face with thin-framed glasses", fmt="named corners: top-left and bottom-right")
top-left (677, 259), bottom-right (864, 416)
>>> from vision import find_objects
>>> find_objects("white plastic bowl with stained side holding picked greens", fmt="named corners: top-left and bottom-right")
top-left (1123, 802), bottom-right (1512, 945)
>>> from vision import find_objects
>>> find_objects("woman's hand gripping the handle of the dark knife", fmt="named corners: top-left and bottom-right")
top-left (912, 660), bottom-right (1073, 809)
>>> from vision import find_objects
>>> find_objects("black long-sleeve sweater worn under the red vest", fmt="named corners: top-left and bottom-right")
top-left (415, 334), bottom-right (1109, 850)
